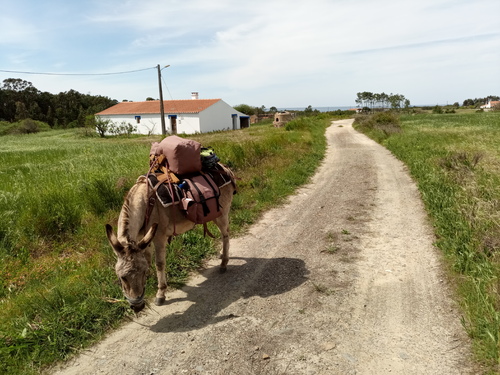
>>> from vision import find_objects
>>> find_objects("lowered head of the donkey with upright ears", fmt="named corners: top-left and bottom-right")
top-left (102, 224), bottom-right (158, 312)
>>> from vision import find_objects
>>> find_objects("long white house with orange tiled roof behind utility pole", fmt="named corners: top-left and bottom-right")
top-left (96, 92), bottom-right (250, 134)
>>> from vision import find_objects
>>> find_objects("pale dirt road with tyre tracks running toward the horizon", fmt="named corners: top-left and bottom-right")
top-left (52, 120), bottom-right (472, 375)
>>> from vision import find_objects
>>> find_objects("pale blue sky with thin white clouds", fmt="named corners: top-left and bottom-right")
top-left (0, 0), bottom-right (500, 108)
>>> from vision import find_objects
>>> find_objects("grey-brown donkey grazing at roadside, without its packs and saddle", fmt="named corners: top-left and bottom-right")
top-left (106, 173), bottom-right (235, 313)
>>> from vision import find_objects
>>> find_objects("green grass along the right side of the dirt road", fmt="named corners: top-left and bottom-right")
top-left (359, 113), bottom-right (500, 373)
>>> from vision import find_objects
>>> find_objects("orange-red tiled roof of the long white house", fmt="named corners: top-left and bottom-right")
top-left (96, 99), bottom-right (221, 115)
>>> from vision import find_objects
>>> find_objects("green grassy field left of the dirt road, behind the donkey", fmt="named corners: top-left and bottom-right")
top-left (0, 115), bottom-right (340, 374)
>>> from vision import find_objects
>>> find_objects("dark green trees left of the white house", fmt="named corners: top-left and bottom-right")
top-left (0, 78), bottom-right (118, 128)
